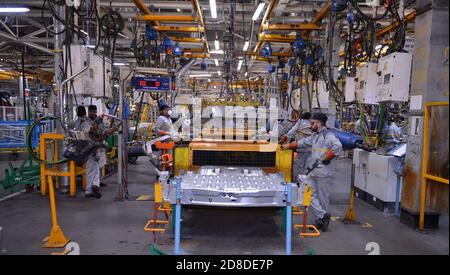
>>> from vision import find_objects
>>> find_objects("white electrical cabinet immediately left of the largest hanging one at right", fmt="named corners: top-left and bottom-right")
top-left (355, 62), bottom-right (378, 104)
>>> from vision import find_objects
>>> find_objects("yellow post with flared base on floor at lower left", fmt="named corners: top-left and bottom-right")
top-left (42, 176), bottom-right (70, 248)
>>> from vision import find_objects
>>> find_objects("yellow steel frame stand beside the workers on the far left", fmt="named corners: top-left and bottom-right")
top-left (39, 133), bottom-right (86, 197)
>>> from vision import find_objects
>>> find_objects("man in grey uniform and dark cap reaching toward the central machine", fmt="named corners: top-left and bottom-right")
top-left (283, 113), bottom-right (342, 232)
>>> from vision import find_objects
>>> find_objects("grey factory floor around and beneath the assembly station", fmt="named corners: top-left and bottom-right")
top-left (0, 157), bottom-right (449, 255)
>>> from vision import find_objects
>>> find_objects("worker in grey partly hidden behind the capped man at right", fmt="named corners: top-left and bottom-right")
top-left (280, 112), bottom-right (312, 179)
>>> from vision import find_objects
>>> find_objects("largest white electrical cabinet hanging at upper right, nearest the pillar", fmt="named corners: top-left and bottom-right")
top-left (376, 52), bottom-right (412, 102)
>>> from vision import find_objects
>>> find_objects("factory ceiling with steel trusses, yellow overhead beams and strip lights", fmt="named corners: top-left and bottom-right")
top-left (0, 0), bottom-right (415, 94)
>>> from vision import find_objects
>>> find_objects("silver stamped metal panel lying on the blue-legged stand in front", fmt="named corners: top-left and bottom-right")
top-left (169, 166), bottom-right (297, 207)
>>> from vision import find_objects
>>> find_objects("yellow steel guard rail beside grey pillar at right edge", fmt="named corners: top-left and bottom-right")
top-left (419, 102), bottom-right (449, 231)
